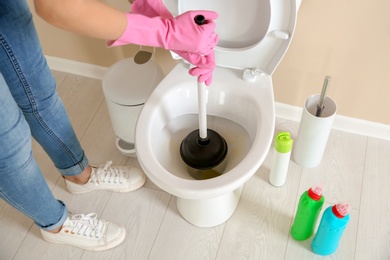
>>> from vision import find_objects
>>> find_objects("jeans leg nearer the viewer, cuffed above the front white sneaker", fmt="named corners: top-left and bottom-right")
top-left (0, 73), bottom-right (68, 229)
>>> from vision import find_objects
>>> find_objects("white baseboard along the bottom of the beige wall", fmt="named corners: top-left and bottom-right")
top-left (46, 56), bottom-right (390, 141)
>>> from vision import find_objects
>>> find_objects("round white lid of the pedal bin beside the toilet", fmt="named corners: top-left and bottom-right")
top-left (102, 57), bottom-right (164, 106)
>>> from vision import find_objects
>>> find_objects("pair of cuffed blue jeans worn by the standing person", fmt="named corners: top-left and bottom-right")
top-left (0, 0), bottom-right (88, 230)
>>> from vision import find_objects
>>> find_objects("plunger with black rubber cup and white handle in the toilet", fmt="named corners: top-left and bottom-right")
top-left (180, 15), bottom-right (228, 174)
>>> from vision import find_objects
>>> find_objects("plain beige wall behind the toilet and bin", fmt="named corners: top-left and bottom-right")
top-left (28, 0), bottom-right (390, 124)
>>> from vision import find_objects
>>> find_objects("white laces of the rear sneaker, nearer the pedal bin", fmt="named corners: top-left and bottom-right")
top-left (90, 161), bottom-right (122, 186)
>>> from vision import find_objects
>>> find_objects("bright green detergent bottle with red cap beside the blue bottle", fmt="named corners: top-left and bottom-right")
top-left (291, 187), bottom-right (325, 240)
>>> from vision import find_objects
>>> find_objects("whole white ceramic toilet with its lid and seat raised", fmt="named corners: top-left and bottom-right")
top-left (135, 0), bottom-right (300, 227)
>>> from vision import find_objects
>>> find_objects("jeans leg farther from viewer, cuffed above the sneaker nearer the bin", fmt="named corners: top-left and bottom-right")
top-left (0, 0), bottom-right (88, 175)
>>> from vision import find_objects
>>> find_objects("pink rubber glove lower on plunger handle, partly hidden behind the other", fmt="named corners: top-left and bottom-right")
top-left (131, 0), bottom-right (215, 86)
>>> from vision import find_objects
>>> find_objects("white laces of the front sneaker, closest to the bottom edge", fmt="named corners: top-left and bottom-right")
top-left (65, 213), bottom-right (103, 238)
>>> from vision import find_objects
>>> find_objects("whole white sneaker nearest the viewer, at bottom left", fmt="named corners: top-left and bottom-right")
top-left (41, 213), bottom-right (126, 251)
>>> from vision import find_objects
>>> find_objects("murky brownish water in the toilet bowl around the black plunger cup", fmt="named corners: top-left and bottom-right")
top-left (153, 114), bottom-right (251, 180)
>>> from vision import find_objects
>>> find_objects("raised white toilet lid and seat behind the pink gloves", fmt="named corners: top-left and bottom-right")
top-left (175, 0), bottom-right (297, 75)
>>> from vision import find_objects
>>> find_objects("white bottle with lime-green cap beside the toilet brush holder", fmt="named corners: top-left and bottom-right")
top-left (269, 132), bottom-right (293, 187)
